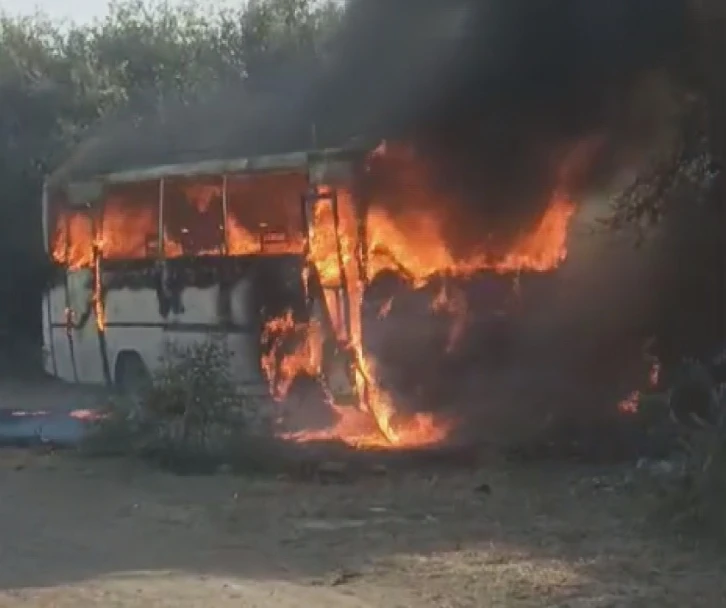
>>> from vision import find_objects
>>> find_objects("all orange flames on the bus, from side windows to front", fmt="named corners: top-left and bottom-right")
top-left (51, 140), bottom-right (575, 448)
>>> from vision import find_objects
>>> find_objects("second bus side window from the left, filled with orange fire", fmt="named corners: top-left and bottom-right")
top-left (100, 181), bottom-right (159, 260)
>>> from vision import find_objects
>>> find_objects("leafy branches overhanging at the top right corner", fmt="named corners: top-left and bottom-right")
top-left (608, 0), bottom-right (726, 234)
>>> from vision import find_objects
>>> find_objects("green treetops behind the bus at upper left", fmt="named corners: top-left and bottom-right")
top-left (0, 0), bottom-right (342, 304)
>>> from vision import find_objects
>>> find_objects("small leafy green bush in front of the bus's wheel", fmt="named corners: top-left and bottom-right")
top-left (83, 339), bottom-right (270, 472)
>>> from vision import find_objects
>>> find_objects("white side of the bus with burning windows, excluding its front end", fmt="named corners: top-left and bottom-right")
top-left (44, 141), bottom-right (370, 391)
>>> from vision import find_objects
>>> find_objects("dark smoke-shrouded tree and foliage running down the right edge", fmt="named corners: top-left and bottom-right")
top-left (610, 0), bottom-right (726, 368)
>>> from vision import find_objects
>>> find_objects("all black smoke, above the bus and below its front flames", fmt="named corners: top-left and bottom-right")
top-left (47, 0), bottom-right (686, 452)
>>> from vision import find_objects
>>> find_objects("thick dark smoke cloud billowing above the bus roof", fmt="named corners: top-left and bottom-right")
top-left (54, 0), bottom-right (685, 191)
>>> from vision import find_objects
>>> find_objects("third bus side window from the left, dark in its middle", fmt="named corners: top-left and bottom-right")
top-left (164, 177), bottom-right (224, 258)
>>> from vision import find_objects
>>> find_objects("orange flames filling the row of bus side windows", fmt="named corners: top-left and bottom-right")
top-left (49, 174), bottom-right (306, 331)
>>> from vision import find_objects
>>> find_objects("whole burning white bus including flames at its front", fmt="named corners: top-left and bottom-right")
top-left (43, 142), bottom-right (575, 445)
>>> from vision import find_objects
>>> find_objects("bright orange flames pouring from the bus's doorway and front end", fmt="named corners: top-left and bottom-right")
top-left (270, 145), bottom-right (575, 448)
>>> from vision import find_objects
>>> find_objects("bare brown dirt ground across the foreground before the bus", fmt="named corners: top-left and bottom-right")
top-left (0, 378), bottom-right (726, 608)
